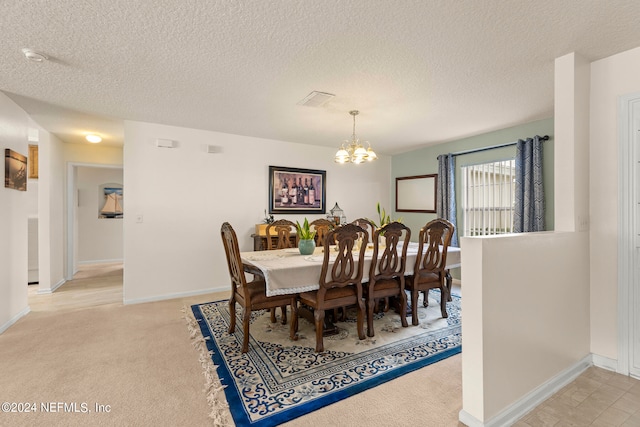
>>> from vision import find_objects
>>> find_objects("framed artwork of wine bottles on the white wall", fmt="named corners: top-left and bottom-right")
top-left (269, 166), bottom-right (327, 214)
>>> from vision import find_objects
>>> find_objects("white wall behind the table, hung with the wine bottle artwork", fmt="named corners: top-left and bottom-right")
top-left (124, 122), bottom-right (391, 302)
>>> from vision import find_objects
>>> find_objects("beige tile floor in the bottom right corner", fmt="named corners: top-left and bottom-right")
top-left (514, 367), bottom-right (640, 427)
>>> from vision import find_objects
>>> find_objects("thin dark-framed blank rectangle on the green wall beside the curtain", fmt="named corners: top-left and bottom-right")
top-left (396, 174), bottom-right (438, 213)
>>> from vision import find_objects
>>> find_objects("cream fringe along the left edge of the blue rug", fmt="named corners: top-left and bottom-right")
top-left (182, 307), bottom-right (234, 427)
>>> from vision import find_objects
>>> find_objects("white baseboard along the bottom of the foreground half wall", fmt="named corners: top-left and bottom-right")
top-left (458, 354), bottom-right (593, 427)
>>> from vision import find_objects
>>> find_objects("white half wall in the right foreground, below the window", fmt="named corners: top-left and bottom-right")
top-left (461, 232), bottom-right (589, 425)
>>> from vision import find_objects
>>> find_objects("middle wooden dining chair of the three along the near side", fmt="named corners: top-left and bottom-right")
top-left (362, 222), bottom-right (411, 337)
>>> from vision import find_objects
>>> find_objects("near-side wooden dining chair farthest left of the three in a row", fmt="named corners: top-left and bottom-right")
top-left (291, 224), bottom-right (369, 353)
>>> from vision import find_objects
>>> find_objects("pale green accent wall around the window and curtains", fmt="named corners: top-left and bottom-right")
top-left (385, 118), bottom-right (554, 278)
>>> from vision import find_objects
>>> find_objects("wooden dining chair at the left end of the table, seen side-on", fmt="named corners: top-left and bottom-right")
top-left (220, 222), bottom-right (295, 353)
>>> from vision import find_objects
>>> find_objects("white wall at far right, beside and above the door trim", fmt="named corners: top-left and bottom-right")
top-left (590, 48), bottom-right (640, 361)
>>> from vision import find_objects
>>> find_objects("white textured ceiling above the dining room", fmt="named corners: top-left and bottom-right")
top-left (0, 0), bottom-right (640, 154)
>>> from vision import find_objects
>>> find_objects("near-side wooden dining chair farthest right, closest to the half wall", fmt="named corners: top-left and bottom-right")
top-left (405, 218), bottom-right (455, 325)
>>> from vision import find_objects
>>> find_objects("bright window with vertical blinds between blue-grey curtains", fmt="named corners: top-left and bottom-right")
top-left (460, 159), bottom-right (515, 236)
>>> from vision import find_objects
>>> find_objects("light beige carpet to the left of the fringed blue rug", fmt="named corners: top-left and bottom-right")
top-left (0, 301), bottom-right (215, 426)
